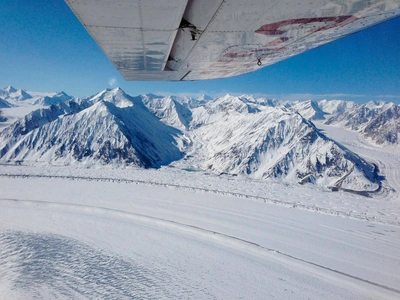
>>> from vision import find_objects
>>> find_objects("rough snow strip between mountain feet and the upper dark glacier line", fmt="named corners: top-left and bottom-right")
top-left (0, 164), bottom-right (400, 225)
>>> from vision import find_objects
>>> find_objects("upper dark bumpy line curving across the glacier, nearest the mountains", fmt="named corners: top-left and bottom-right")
top-left (0, 174), bottom-right (400, 226)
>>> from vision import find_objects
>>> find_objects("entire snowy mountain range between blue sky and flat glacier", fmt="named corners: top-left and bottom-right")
top-left (0, 87), bottom-right (400, 191)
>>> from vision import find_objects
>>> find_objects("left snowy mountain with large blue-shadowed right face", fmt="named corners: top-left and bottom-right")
top-left (0, 89), bottom-right (186, 167)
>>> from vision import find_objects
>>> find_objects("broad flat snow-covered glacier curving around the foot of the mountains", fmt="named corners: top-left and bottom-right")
top-left (0, 124), bottom-right (400, 299)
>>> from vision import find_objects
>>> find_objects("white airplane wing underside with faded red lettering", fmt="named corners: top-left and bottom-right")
top-left (65, 0), bottom-right (400, 81)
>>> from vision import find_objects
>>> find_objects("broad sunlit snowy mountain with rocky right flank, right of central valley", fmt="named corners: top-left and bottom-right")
top-left (194, 97), bottom-right (378, 190)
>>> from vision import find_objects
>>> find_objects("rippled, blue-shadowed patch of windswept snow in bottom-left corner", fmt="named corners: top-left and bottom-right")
top-left (0, 231), bottom-right (181, 299)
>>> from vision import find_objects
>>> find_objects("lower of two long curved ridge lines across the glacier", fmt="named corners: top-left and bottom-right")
top-left (0, 198), bottom-right (400, 298)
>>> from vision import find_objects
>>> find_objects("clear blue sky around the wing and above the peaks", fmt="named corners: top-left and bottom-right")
top-left (0, 0), bottom-right (400, 103)
